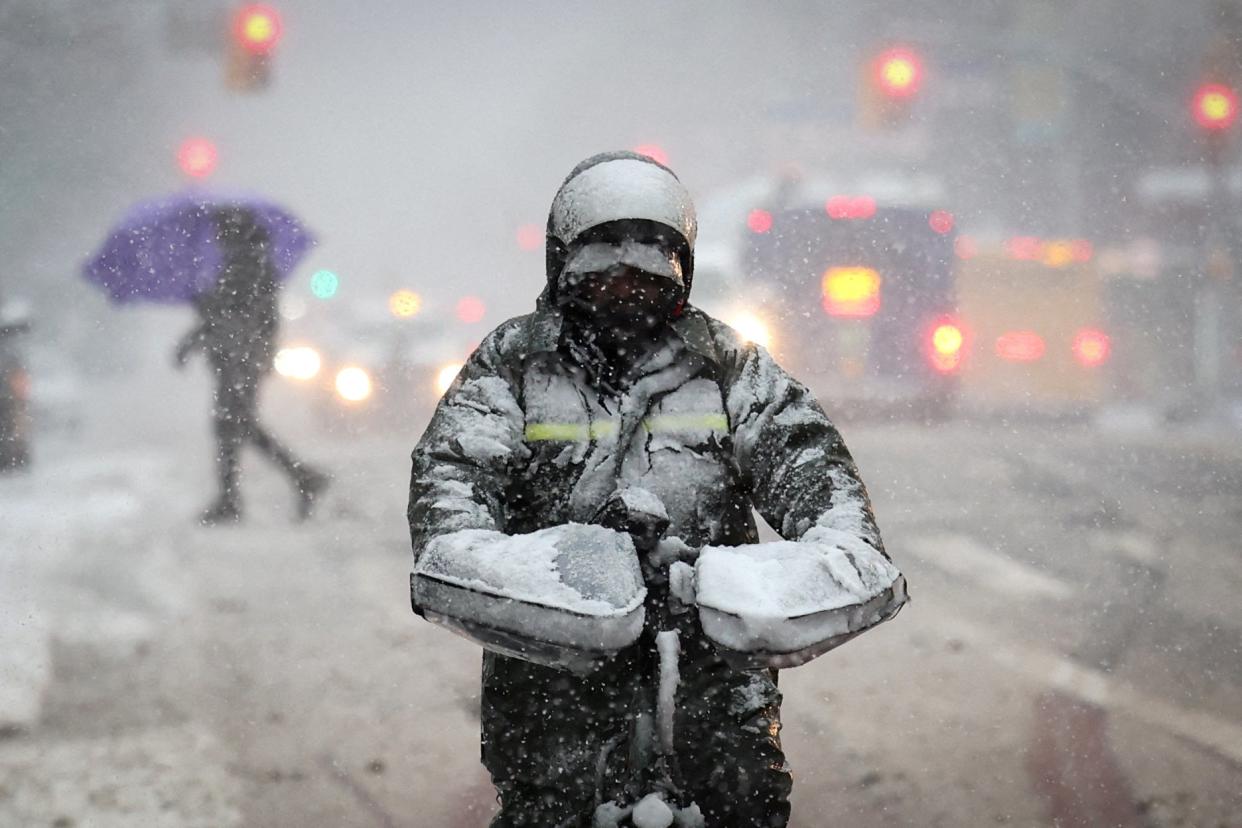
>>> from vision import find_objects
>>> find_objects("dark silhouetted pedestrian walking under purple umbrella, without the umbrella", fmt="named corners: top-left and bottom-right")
top-left (175, 207), bottom-right (328, 525)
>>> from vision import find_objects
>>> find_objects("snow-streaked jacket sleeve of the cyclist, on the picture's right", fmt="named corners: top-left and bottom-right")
top-left (717, 331), bottom-right (888, 559)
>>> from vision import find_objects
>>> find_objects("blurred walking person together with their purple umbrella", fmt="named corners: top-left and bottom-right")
top-left (83, 192), bottom-right (329, 525)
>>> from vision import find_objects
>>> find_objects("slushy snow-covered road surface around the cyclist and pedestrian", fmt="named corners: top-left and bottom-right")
top-left (0, 377), bottom-right (1242, 827)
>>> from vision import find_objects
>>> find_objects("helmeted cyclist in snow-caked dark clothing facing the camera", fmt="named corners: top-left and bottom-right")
top-left (409, 153), bottom-right (887, 828)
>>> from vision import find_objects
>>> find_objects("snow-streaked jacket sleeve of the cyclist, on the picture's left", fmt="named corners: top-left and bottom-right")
top-left (407, 328), bottom-right (528, 560)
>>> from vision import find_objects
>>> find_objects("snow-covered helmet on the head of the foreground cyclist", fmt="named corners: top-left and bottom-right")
top-left (546, 151), bottom-right (698, 302)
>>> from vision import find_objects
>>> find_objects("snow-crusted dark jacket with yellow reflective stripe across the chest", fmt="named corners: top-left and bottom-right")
top-left (409, 303), bottom-right (887, 559)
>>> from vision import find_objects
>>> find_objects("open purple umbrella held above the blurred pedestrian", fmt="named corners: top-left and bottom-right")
top-left (82, 191), bottom-right (314, 304)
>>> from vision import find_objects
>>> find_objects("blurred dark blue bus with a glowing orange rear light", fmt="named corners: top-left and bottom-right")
top-left (725, 195), bottom-right (965, 416)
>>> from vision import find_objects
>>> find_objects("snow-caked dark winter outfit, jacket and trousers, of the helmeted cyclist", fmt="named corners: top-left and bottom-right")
top-left (409, 303), bottom-right (883, 826)
